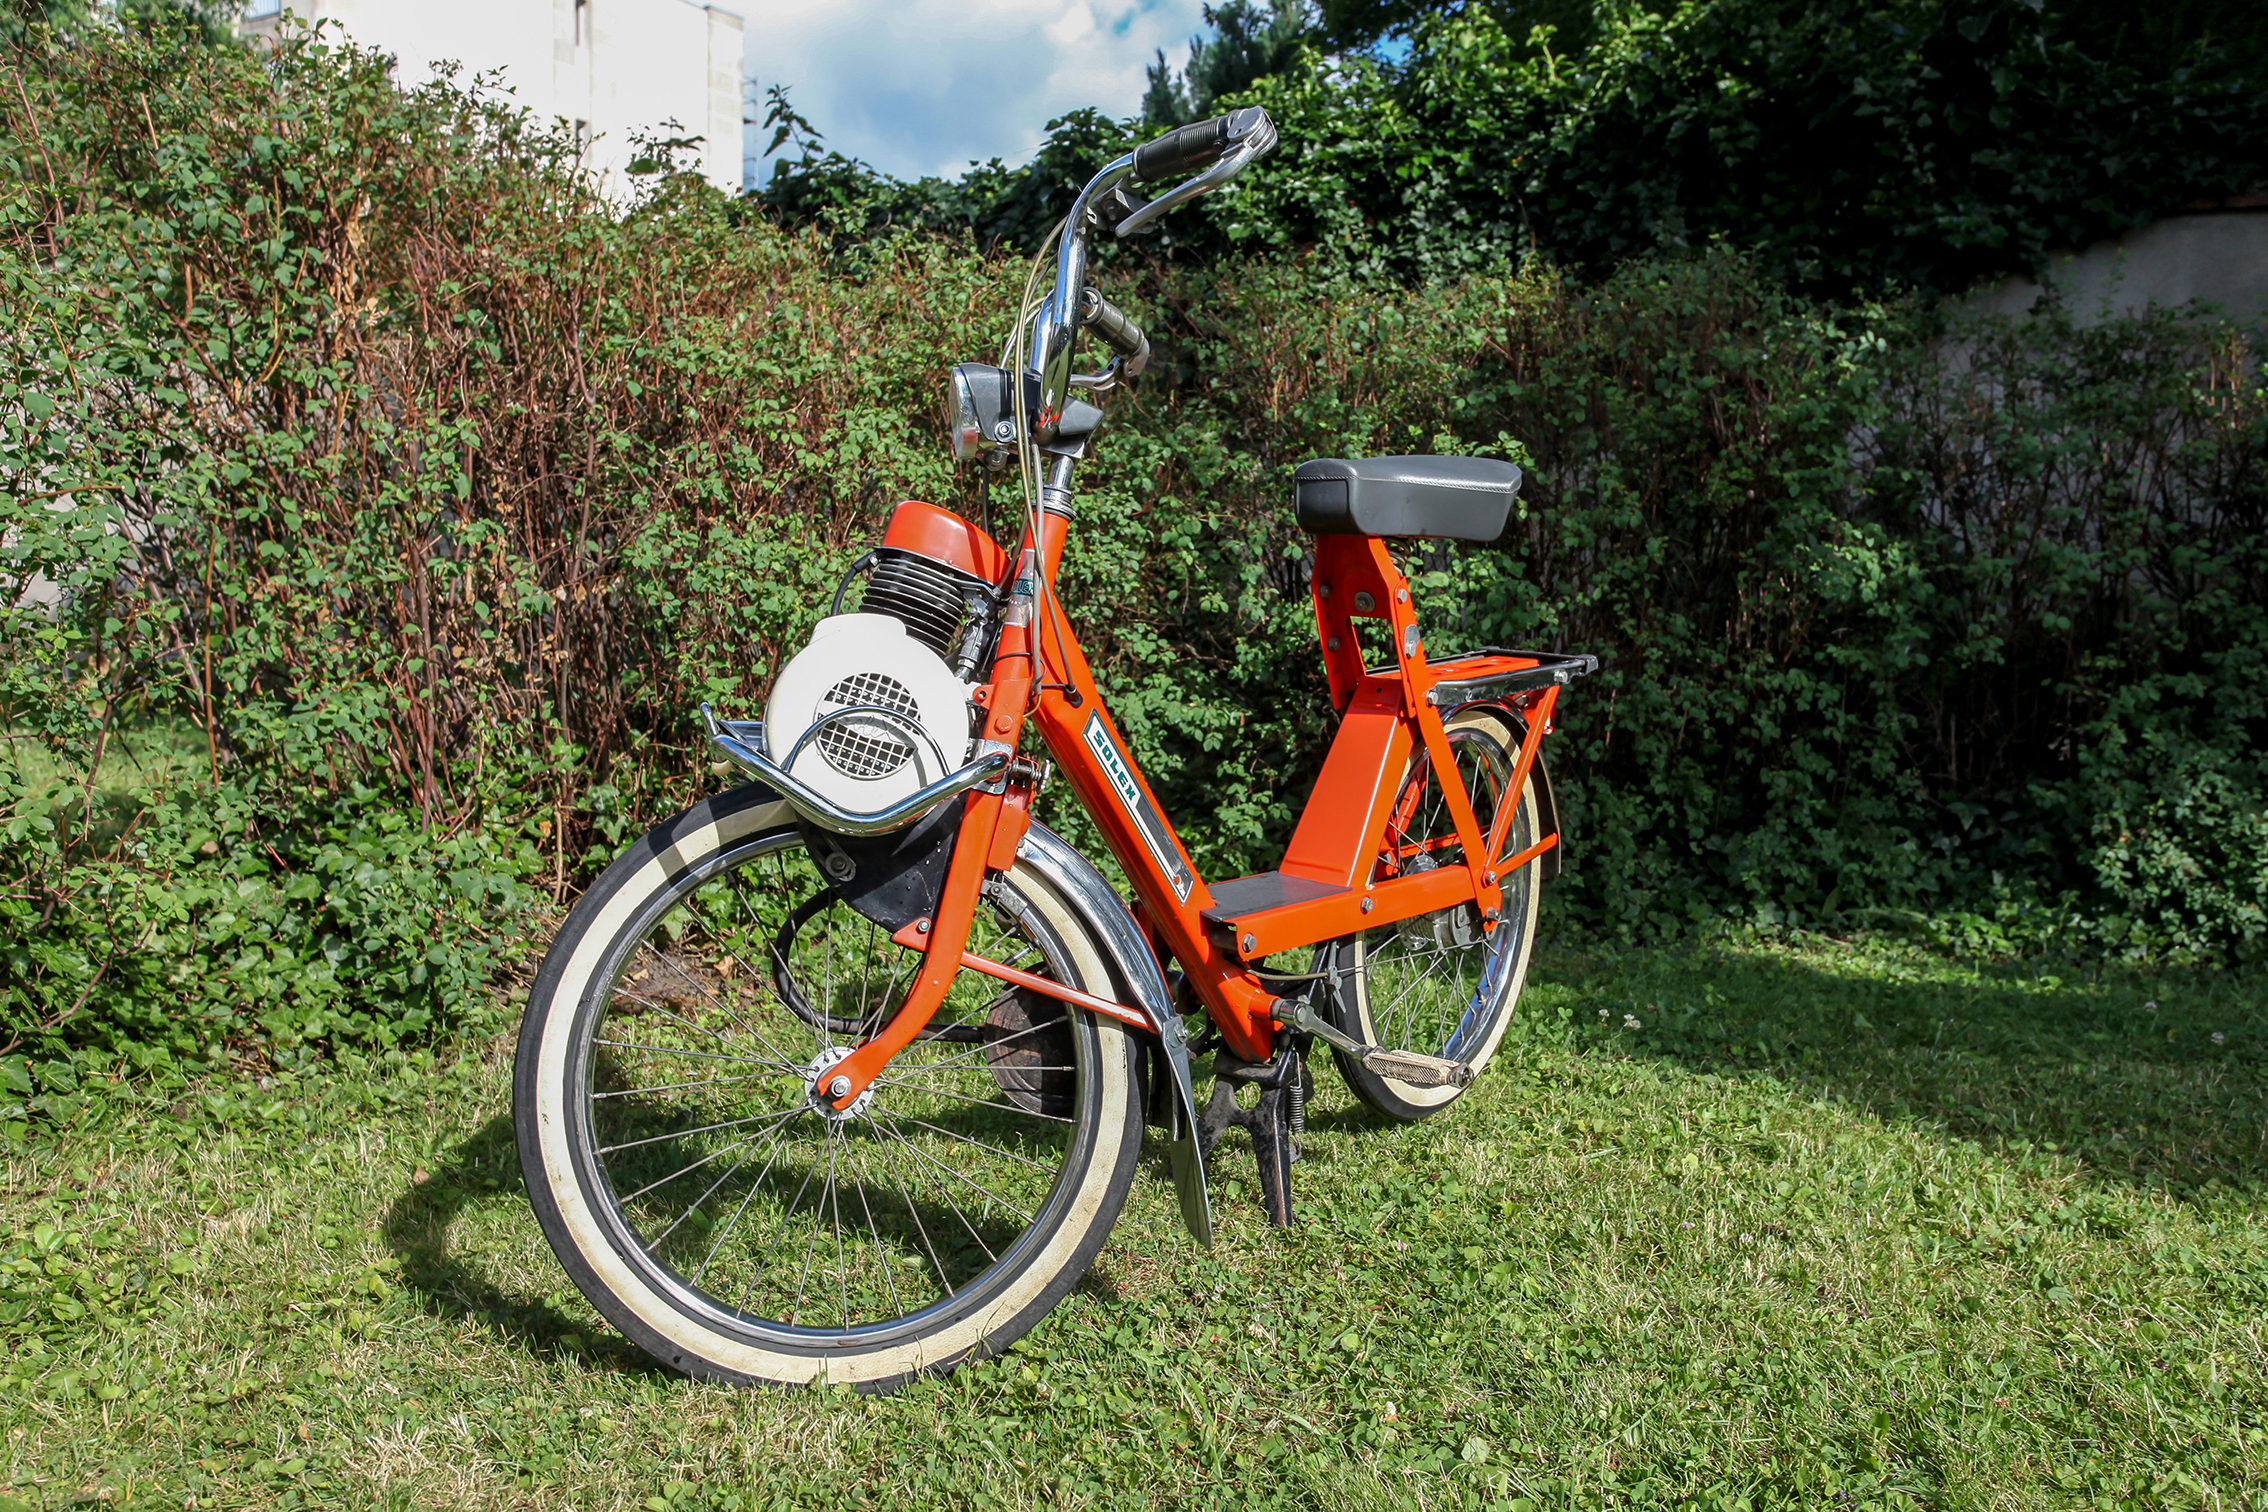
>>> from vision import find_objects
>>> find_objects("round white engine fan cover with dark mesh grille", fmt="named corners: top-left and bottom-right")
top-left (764, 614), bottom-right (975, 812)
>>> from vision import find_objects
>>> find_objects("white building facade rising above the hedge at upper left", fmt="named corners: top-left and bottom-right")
top-left (240, 0), bottom-right (742, 195)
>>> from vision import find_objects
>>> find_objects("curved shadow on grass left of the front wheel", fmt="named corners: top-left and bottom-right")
top-left (383, 1113), bottom-right (667, 1376)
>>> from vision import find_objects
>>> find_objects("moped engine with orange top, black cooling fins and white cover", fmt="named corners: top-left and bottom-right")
top-left (764, 501), bottom-right (1007, 812)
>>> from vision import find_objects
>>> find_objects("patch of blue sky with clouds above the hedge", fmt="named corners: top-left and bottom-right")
top-left (726, 0), bottom-right (1204, 177)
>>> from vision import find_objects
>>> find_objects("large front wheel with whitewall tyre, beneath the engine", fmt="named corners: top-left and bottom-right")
top-left (513, 787), bottom-right (1141, 1390)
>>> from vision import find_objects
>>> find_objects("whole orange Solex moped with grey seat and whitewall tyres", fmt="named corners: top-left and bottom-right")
top-left (515, 109), bottom-right (1597, 1390)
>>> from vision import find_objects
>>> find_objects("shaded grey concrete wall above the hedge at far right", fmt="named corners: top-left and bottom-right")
top-left (1962, 205), bottom-right (2268, 320)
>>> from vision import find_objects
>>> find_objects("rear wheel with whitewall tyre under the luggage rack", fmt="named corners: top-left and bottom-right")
top-left (1315, 710), bottom-right (1542, 1120)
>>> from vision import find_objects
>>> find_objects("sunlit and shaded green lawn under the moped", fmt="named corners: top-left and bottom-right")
top-left (0, 941), bottom-right (2268, 1510)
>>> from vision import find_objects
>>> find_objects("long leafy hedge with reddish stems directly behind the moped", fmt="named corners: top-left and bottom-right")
top-left (0, 32), bottom-right (2268, 1097)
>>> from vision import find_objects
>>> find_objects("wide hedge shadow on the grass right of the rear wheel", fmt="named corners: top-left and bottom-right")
top-left (1529, 943), bottom-right (2268, 1195)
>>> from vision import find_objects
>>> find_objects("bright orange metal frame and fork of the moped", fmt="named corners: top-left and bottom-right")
top-left (830, 512), bottom-right (1558, 1108)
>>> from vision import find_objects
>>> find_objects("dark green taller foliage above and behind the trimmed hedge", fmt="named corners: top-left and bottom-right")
top-left (764, 0), bottom-right (2268, 299)
